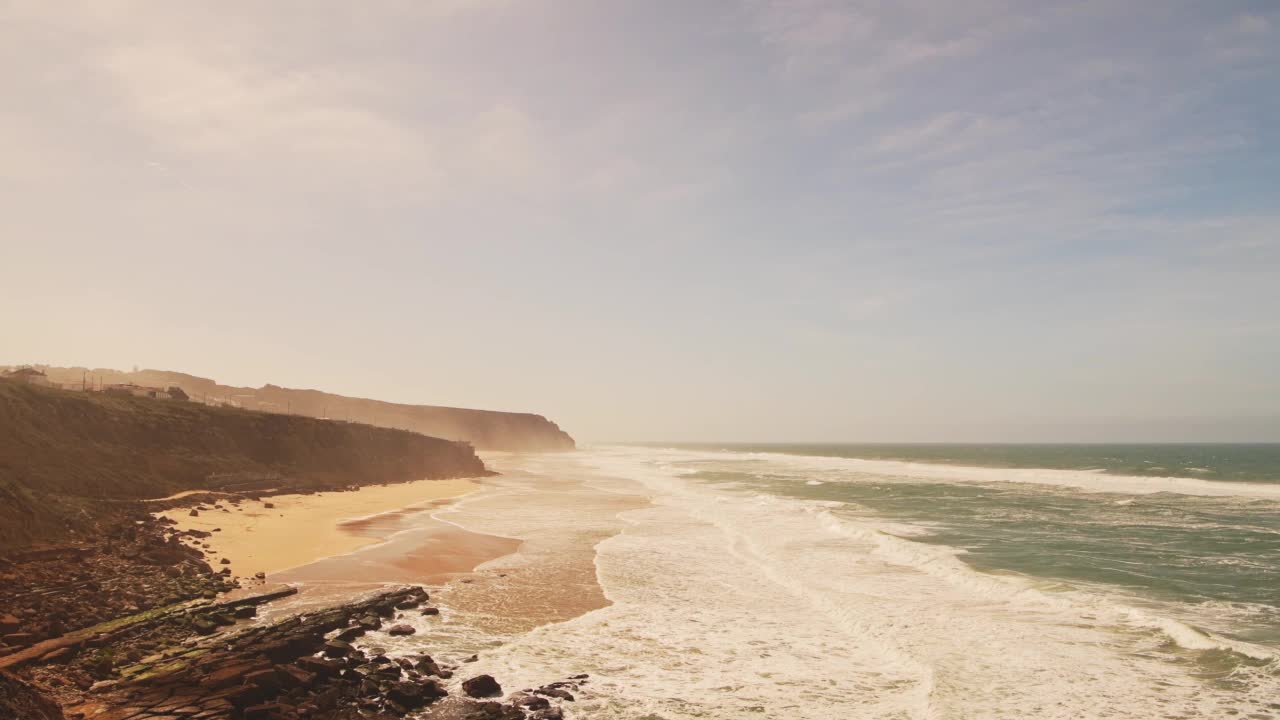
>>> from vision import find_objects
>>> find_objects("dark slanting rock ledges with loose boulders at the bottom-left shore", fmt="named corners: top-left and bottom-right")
top-left (11, 588), bottom-right (577, 720)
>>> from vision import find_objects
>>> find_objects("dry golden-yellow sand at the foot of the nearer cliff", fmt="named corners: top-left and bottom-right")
top-left (159, 479), bottom-right (483, 579)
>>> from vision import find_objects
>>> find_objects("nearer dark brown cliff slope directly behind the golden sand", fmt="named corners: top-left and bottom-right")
top-left (0, 380), bottom-right (486, 547)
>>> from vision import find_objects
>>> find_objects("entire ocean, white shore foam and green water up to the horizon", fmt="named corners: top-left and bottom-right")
top-left (371, 445), bottom-right (1280, 720)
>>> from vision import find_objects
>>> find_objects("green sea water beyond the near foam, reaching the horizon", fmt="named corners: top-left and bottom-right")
top-left (660, 445), bottom-right (1280, 647)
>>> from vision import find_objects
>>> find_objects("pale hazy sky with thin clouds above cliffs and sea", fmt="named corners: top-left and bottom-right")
top-left (0, 0), bottom-right (1280, 442)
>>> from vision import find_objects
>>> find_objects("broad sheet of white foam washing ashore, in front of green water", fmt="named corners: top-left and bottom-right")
top-left (448, 450), bottom-right (1276, 720)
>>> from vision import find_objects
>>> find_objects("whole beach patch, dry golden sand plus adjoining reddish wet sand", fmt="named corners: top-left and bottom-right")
top-left (160, 479), bottom-right (494, 582)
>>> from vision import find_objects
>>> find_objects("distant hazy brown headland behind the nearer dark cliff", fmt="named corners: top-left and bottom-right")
top-left (26, 368), bottom-right (575, 451)
